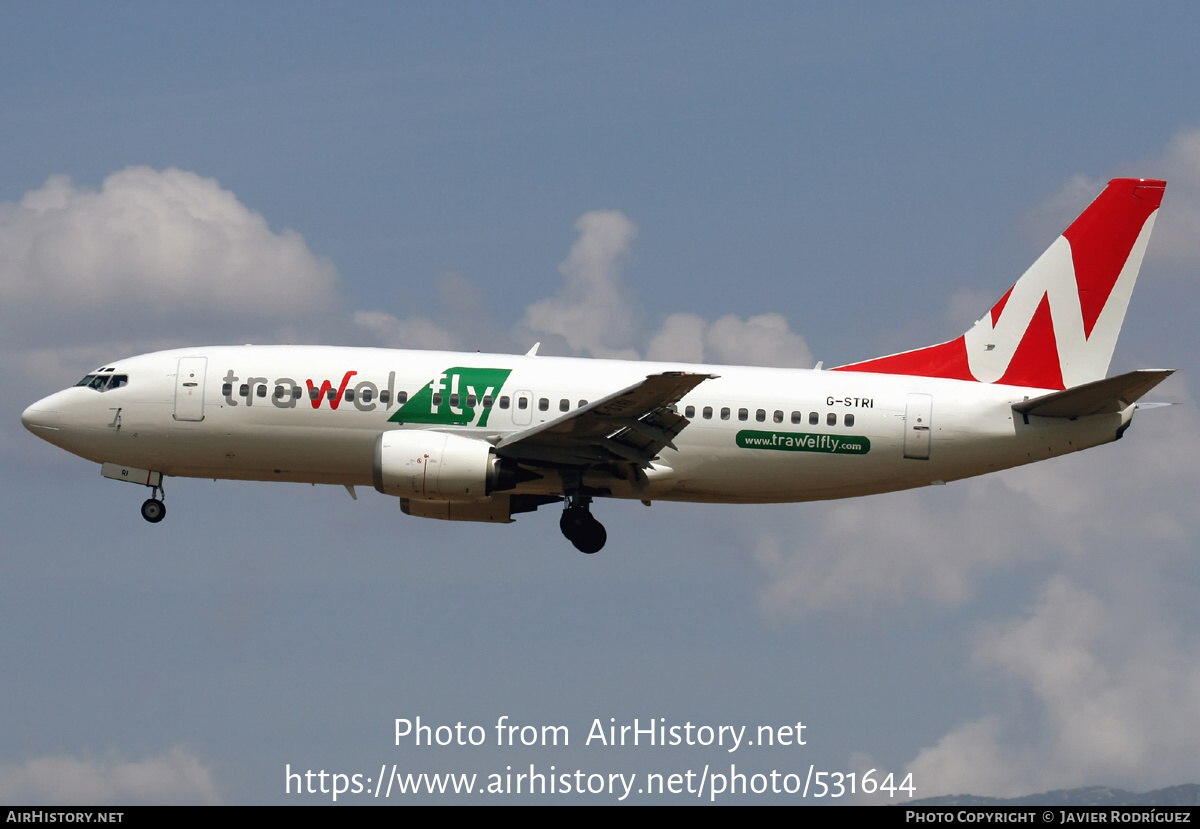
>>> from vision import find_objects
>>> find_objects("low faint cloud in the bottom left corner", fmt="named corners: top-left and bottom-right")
top-left (0, 746), bottom-right (221, 806)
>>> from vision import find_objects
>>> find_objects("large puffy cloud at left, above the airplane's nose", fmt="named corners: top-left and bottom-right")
top-left (0, 167), bottom-right (336, 316)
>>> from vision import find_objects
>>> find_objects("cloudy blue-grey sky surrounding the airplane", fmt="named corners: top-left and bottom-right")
top-left (0, 2), bottom-right (1200, 804)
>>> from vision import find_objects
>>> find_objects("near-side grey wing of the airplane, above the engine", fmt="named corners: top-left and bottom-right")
top-left (496, 372), bottom-right (715, 469)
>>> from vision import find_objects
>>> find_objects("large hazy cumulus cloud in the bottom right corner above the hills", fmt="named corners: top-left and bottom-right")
top-left (908, 576), bottom-right (1200, 797)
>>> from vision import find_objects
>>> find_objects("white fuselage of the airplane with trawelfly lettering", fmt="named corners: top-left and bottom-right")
top-left (23, 346), bottom-right (1134, 503)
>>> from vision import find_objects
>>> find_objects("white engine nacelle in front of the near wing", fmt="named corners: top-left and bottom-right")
top-left (372, 429), bottom-right (504, 501)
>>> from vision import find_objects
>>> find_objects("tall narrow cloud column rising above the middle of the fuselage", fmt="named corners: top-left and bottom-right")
top-left (522, 210), bottom-right (637, 360)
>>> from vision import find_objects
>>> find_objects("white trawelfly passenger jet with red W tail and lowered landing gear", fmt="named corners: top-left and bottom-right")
top-left (22, 179), bottom-right (1172, 553)
